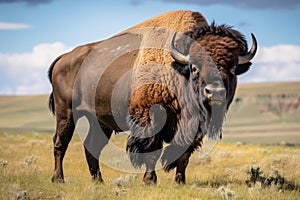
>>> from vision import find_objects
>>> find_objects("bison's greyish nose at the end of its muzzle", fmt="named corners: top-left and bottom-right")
top-left (204, 84), bottom-right (226, 105)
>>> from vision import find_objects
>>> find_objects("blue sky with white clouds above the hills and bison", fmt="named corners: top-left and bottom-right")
top-left (0, 0), bottom-right (300, 95)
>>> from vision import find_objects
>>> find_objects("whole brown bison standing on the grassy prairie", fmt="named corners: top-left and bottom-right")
top-left (48, 11), bottom-right (257, 184)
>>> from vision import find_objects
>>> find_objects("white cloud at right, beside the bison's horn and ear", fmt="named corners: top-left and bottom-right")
top-left (240, 45), bottom-right (300, 83)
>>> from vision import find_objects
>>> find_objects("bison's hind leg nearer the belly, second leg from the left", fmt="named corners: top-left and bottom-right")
top-left (84, 115), bottom-right (112, 183)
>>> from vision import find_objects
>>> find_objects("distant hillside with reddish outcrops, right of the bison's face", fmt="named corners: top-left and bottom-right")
top-left (224, 82), bottom-right (300, 144)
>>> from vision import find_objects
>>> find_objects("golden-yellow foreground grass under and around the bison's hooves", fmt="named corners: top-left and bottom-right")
top-left (0, 133), bottom-right (300, 199)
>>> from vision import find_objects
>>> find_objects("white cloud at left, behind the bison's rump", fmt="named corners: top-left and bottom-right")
top-left (0, 42), bottom-right (70, 95)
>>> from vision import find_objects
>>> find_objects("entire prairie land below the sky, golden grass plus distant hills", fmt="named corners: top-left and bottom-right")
top-left (0, 82), bottom-right (300, 200)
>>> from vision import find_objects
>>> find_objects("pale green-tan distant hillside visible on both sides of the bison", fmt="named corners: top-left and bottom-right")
top-left (0, 82), bottom-right (300, 144)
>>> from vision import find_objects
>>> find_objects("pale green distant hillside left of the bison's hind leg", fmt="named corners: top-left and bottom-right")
top-left (0, 95), bottom-right (55, 133)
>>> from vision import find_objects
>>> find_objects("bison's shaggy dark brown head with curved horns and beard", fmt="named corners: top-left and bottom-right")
top-left (170, 23), bottom-right (257, 139)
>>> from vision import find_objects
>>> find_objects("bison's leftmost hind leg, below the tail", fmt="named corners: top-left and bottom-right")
top-left (51, 109), bottom-right (75, 183)
